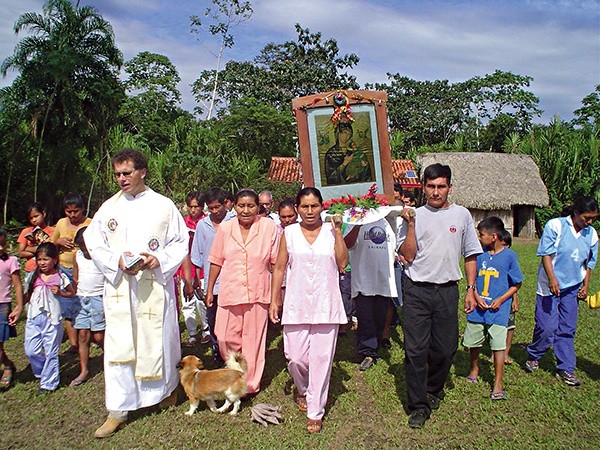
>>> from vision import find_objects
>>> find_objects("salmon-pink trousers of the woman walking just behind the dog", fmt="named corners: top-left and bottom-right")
top-left (215, 303), bottom-right (269, 394)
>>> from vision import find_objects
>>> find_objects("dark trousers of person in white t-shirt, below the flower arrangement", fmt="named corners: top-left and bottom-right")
top-left (354, 294), bottom-right (392, 358)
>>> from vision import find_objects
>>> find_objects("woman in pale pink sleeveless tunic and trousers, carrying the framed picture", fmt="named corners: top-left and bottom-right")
top-left (269, 187), bottom-right (348, 433)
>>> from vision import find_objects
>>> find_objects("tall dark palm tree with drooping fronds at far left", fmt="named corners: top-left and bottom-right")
top-left (0, 0), bottom-right (124, 200)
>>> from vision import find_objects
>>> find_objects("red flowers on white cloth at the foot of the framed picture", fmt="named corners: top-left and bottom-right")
top-left (324, 184), bottom-right (403, 225)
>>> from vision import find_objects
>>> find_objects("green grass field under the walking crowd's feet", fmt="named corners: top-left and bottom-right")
top-left (0, 241), bottom-right (600, 449)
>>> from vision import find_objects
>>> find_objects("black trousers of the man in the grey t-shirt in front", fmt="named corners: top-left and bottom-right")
top-left (402, 276), bottom-right (458, 411)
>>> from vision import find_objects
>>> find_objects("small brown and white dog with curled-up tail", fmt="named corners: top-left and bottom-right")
top-left (177, 352), bottom-right (248, 416)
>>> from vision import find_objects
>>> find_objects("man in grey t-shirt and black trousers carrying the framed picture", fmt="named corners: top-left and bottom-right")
top-left (400, 164), bottom-right (482, 428)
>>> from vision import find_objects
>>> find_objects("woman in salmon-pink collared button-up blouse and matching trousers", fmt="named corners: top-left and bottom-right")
top-left (206, 189), bottom-right (279, 394)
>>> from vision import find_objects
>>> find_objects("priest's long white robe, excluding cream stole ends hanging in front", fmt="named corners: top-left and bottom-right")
top-left (84, 188), bottom-right (189, 411)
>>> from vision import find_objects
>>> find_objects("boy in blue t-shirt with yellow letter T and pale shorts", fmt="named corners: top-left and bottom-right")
top-left (463, 217), bottom-right (523, 400)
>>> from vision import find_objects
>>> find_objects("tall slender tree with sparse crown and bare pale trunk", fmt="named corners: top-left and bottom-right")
top-left (190, 0), bottom-right (254, 119)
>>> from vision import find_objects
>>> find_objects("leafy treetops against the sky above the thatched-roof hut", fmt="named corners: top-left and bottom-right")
top-left (367, 70), bottom-right (541, 153)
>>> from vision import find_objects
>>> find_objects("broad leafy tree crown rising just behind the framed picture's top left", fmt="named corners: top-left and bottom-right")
top-left (192, 24), bottom-right (359, 113)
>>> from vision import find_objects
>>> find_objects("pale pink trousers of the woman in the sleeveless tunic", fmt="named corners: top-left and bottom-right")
top-left (283, 324), bottom-right (340, 419)
